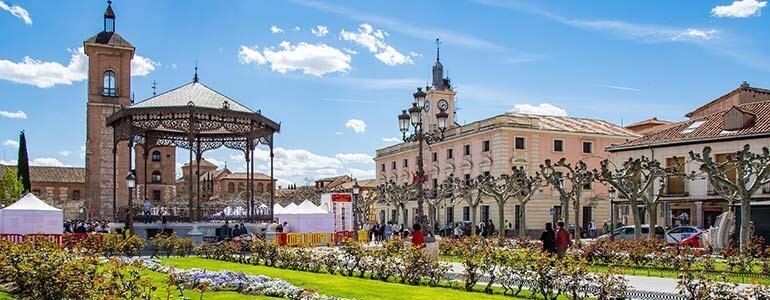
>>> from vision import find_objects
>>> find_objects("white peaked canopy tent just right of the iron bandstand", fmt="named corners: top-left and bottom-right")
top-left (275, 200), bottom-right (334, 232)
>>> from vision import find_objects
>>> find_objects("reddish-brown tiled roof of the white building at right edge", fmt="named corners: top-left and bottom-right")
top-left (607, 101), bottom-right (770, 152)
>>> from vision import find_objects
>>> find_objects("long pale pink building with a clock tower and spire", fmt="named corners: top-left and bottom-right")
top-left (374, 50), bottom-right (638, 233)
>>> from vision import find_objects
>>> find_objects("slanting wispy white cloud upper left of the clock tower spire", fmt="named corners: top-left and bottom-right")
top-left (340, 24), bottom-right (414, 66)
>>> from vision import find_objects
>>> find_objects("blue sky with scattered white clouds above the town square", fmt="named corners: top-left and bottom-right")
top-left (0, 0), bottom-right (770, 184)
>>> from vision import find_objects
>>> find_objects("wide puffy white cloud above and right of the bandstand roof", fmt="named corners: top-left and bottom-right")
top-left (238, 41), bottom-right (351, 77)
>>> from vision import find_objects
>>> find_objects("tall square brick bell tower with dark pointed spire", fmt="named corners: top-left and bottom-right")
top-left (83, 1), bottom-right (135, 221)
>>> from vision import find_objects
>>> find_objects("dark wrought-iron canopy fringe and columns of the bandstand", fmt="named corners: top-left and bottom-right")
top-left (107, 85), bottom-right (281, 221)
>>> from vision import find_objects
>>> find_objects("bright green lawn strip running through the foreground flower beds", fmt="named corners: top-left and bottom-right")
top-left (162, 257), bottom-right (530, 300)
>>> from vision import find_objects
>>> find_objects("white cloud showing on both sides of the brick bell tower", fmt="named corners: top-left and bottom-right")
top-left (0, 47), bottom-right (160, 88)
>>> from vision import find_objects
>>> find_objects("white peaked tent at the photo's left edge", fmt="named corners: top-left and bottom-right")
top-left (0, 193), bottom-right (64, 234)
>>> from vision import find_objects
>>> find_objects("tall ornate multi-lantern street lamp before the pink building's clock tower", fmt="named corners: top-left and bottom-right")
top-left (398, 88), bottom-right (449, 237)
